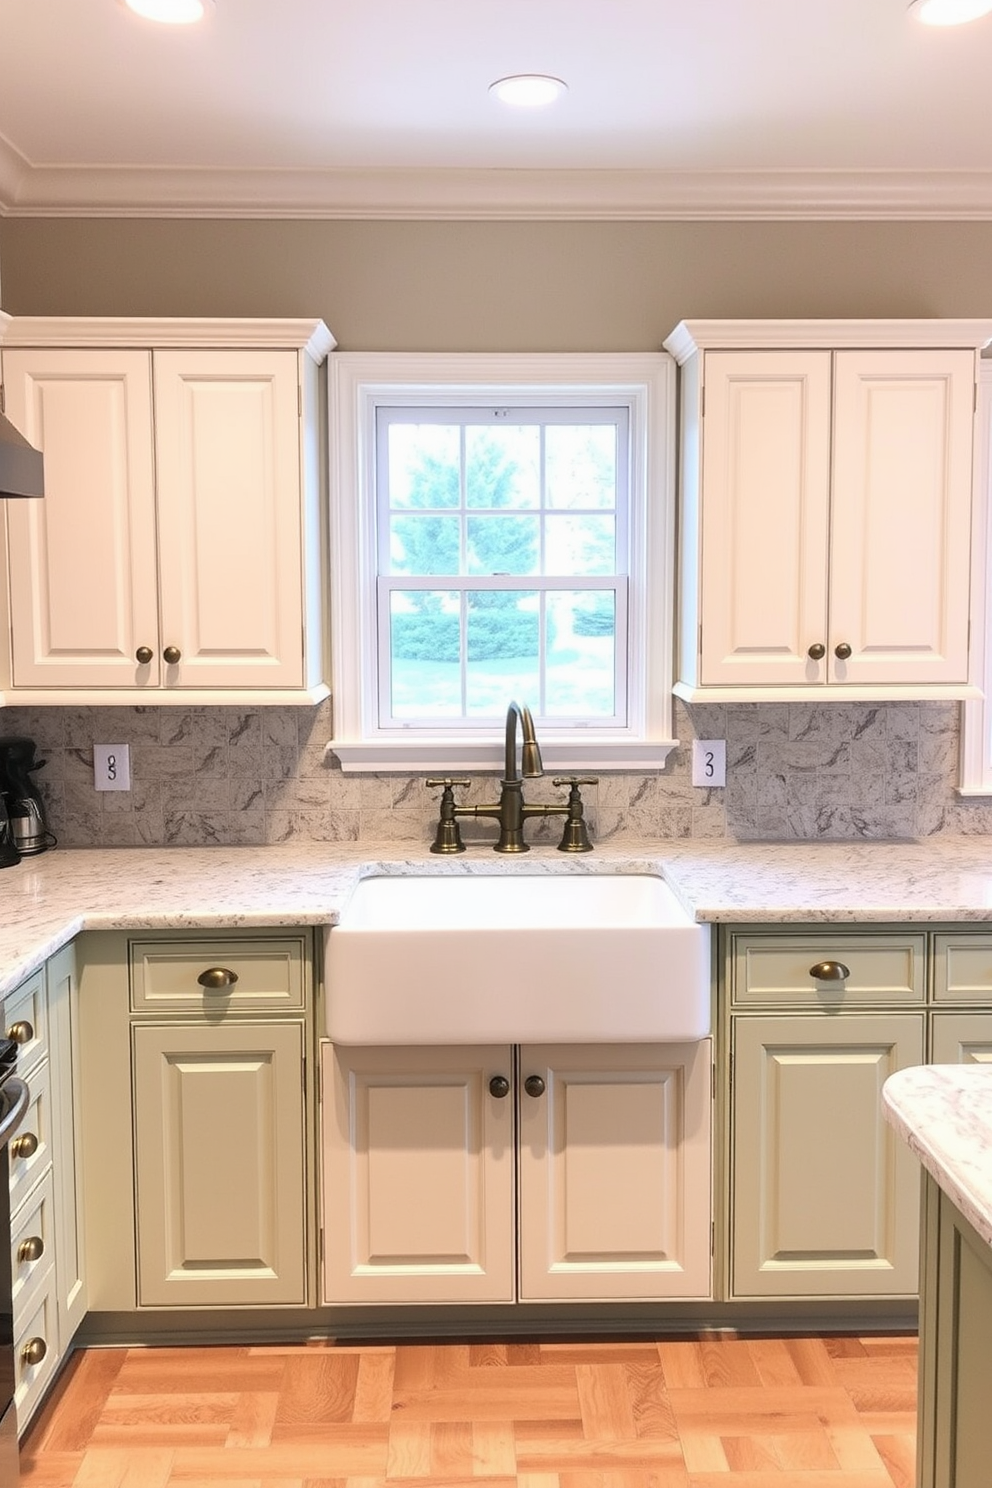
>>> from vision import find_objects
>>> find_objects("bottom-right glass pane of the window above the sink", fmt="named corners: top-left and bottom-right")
top-left (544, 589), bottom-right (616, 719)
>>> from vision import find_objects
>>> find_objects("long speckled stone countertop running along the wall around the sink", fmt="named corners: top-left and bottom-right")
top-left (0, 836), bottom-right (992, 995)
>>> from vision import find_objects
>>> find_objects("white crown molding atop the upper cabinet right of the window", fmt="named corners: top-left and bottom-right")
top-left (665, 320), bottom-right (992, 366)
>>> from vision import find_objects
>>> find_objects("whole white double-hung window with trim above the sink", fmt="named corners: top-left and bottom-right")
top-left (332, 354), bottom-right (674, 769)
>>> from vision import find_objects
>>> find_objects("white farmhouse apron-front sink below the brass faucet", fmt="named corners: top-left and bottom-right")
top-left (326, 873), bottom-right (711, 1045)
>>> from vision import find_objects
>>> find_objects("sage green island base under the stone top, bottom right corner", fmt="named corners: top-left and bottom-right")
top-left (916, 1174), bottom-right (992, 1488)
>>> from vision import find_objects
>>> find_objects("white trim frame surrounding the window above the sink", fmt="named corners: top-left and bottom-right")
top-left (327, 353), bottom-right (678, 774)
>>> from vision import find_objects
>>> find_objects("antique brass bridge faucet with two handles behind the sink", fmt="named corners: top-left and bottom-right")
top-left (427, 702), bottom-right (598, 853)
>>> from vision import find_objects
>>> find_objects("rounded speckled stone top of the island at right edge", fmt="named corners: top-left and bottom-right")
top-left (882, 1064), bottom-right (992, 1245)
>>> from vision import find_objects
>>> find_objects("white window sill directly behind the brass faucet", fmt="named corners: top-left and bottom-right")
top-left (326, 737), bottom-right (678, 775)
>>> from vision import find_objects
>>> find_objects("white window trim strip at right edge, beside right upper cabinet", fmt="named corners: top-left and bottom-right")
top-left (958, 359), bottom-right (992, 796)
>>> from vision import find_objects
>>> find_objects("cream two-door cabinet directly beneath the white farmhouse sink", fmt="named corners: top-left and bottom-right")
top-left (321, 1039), bottom-right (712, 1303)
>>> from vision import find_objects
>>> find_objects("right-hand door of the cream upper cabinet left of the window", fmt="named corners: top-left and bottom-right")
top-left (153, 350), bottom-right (303, 687)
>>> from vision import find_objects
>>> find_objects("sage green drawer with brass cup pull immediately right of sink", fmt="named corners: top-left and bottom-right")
top-left (730, 931), bottom-right (927, 1009)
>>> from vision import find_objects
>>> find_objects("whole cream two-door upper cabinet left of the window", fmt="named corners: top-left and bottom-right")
top-left (3, 318), bottom-right (333, 702)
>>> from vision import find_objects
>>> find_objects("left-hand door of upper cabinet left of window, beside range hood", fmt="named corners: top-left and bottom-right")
top-left (3, 348), bottom-right (159, 689)
